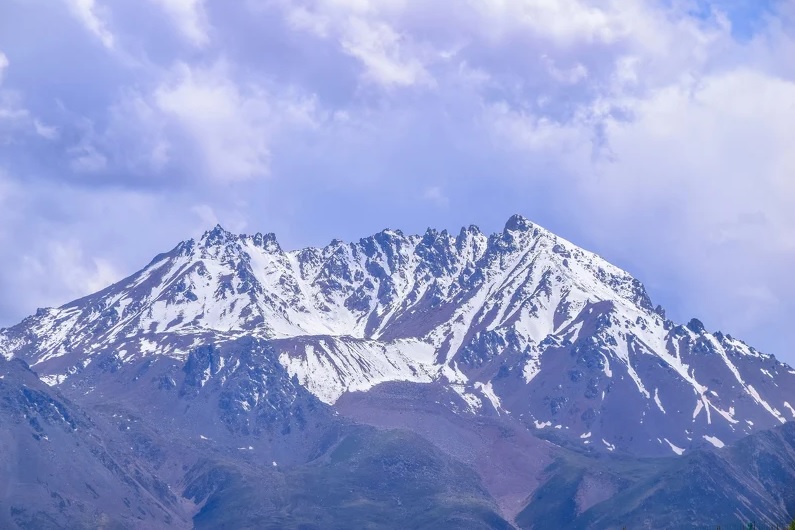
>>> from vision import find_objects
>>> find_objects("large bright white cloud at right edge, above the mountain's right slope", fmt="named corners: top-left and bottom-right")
top-left (587, 68), bottom-right (795, 251)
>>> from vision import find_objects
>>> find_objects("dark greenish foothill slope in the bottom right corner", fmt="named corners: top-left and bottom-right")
top-left (516, 422), bottom-right (795, 529)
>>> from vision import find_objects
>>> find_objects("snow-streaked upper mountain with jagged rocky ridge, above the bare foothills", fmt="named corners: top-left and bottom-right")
top-left (0, 216), bottom-right (795, 454)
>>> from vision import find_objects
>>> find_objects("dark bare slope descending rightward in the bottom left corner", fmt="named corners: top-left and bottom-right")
top-left (0, 358), bottom-right (190, 530)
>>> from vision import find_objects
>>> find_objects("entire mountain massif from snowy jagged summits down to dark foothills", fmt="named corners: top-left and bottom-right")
top-left (0, 216), bottom-right (795, 528)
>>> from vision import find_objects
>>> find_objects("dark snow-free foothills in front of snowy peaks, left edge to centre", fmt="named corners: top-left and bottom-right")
top-left (0, 348), bottom-right (510, 530)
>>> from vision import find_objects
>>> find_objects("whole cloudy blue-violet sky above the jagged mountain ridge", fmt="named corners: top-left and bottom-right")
top-left (0, 0), bottom-right (795, 364)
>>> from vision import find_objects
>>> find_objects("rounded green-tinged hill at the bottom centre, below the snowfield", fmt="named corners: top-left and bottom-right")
top-left (185, 427), bottom-right (511, 529)
